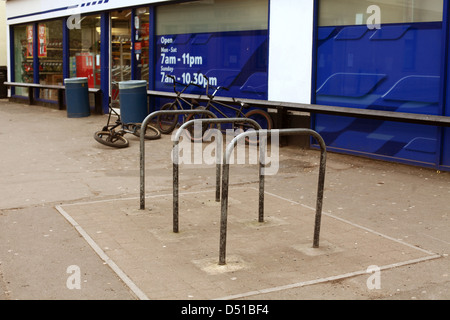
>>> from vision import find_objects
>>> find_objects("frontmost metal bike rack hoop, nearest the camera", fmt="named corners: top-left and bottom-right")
top-left (219, 129), bottom-right (326, 265)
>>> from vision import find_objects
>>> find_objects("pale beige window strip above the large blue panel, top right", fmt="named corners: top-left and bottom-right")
top-left (319, 0), bottom-right (443, 26)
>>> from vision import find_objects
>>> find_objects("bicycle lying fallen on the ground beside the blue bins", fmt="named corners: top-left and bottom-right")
top-left (94, 82), bottom-right (161, 148)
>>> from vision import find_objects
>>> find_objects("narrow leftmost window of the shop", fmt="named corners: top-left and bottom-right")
top-left (14, 24), bottom-right (34, 95)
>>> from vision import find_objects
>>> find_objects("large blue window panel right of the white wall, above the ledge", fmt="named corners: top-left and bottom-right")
top-left (316, 22), bottom-right (442, 115)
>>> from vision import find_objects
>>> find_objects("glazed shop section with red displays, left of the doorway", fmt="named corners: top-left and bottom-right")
top-left (10, 10), bottom-right (101, 104)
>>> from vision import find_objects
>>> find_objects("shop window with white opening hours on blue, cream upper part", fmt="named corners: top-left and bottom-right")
top-left (155, 0), bottom-right (269, 99)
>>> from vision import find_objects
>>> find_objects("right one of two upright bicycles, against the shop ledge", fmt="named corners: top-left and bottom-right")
top-left (186, 75), bottom-right (273, 142)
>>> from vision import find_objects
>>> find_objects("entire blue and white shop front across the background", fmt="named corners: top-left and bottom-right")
top-left (7, 0), bottom-right (450, 170)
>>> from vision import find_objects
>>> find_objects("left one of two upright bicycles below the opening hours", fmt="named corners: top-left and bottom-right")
top-left (156, 75), bottom-right (201, 134)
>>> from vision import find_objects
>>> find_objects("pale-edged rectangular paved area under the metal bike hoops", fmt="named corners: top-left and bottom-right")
top-left (57, 187), bottom-right (439, 300)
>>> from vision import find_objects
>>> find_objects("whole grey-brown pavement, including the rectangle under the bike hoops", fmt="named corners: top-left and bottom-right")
top-left (0, 100), bottom-right (450, 300)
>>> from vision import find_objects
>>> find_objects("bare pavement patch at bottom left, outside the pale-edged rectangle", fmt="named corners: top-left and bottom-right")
top-left (0, 206), bottom-right (136, 300)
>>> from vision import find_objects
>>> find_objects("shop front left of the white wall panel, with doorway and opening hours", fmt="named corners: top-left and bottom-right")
top-left (7, 0), bottom-right (269, 113)
